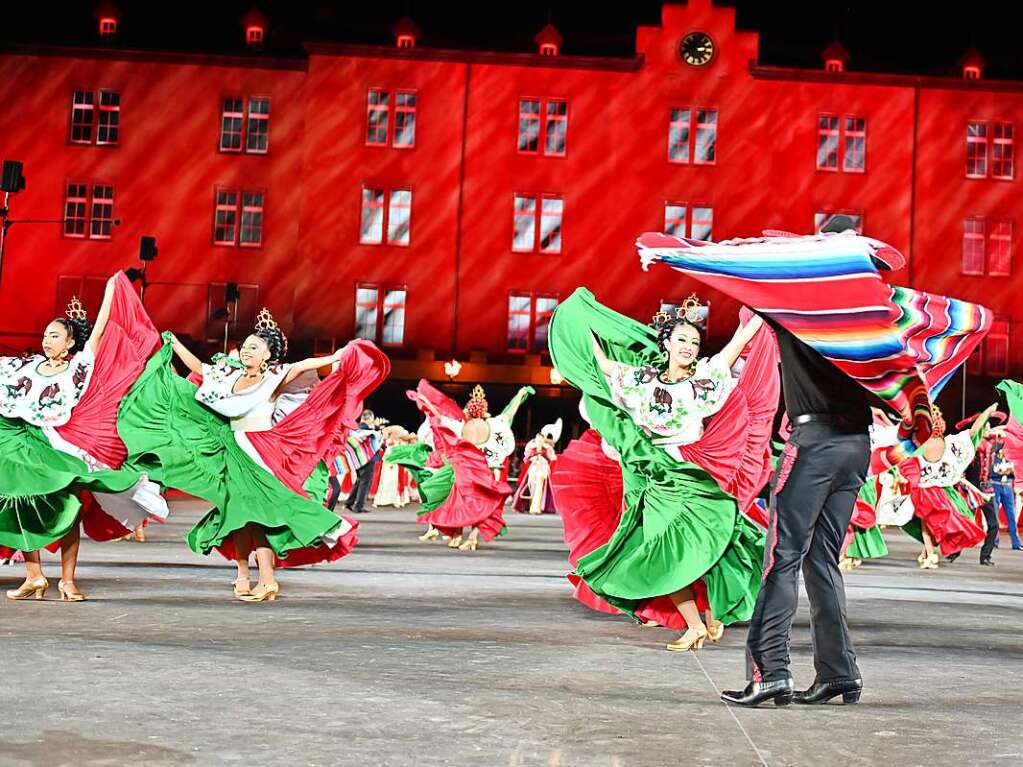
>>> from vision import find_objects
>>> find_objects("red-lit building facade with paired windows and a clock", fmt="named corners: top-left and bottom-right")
top-left (0, 0), bottom-right (1023, 398)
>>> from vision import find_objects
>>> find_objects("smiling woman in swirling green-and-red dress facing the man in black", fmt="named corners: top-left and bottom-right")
top-left (550, 288), bottom-right (779, 650)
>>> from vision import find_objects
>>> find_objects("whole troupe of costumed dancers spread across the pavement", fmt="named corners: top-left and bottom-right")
top-left (0, 218), bottom-right (1023, 705)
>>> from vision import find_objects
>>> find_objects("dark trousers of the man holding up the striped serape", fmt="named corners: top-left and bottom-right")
top-left (746, 423), bottom-right (870, 681)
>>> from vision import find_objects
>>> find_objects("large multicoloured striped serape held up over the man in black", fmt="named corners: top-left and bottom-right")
top-left (636, 231), bottom-right (991, 463)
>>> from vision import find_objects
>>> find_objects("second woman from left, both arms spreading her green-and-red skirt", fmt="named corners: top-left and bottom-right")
top-left (119, 310), bottom-right (390, 602)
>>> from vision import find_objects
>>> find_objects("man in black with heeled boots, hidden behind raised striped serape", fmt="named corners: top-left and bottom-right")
top-left (721, 216), bottom-right (871, 706)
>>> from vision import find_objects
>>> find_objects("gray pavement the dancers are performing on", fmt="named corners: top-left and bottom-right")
top-left (0, 502), bottom-right (1023, 767)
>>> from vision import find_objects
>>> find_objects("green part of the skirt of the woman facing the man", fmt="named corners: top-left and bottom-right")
top-left (550, 288), bottom-right (764, 624)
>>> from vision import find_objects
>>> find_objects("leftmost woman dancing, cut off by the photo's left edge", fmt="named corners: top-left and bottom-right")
top-left (0, 272), bottom-right (167, 601)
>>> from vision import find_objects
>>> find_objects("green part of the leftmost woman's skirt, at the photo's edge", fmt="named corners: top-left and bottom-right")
top-left (0, 416), bottom-right (141, 551)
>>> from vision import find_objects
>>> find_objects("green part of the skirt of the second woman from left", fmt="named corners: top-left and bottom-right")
top-left (118, 337), bottom-right (342, 559)
